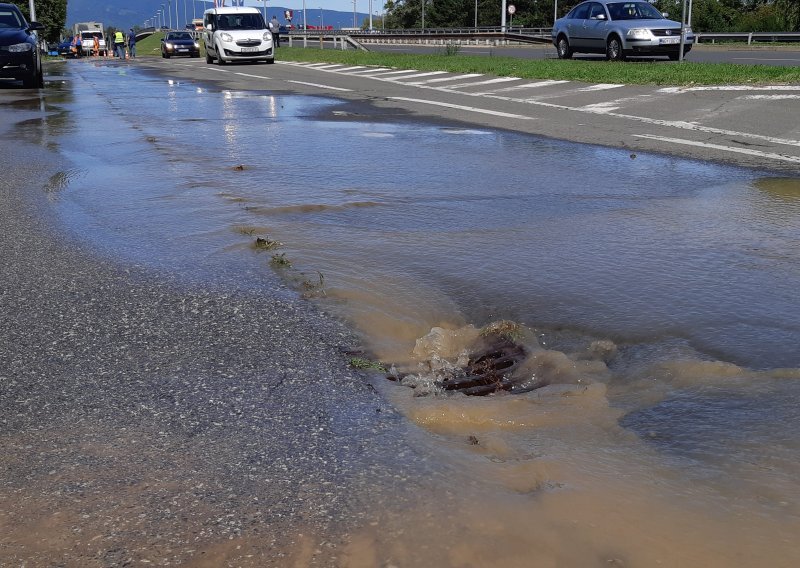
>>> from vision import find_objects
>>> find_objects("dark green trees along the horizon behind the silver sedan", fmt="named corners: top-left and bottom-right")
top-left (385, 0), bottom-right (800, 32)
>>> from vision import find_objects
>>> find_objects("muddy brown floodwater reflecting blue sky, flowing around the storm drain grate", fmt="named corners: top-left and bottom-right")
top-left (45, 63), bottom-right (800, 566)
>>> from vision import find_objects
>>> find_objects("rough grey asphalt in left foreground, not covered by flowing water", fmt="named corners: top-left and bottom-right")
top-left (0, 82), bottom-right (438, 566)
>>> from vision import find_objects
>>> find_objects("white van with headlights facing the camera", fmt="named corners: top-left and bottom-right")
top-left (203, 7), bottom-right (275, 65)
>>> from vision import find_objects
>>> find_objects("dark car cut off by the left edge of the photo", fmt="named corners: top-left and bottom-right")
top-left (0, 4), bottom-right (44, 89)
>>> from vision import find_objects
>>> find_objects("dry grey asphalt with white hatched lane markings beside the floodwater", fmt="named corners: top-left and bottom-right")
top-left (138, 56), bottom-right (800, 174)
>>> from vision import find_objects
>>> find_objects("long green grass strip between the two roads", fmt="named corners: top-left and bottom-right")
top-left (277, 46), bottom-right (800, 85)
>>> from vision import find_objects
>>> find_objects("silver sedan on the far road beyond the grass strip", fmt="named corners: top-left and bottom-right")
top-left (552, 0), bottom-right (694, 61)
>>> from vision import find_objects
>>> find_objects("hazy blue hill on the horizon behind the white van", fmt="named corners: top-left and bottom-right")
top-left (67, 0), bottom-right (369, 29)
